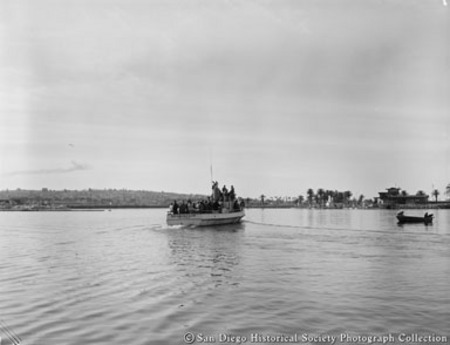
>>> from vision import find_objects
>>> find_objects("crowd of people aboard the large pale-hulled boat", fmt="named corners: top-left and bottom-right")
top-left (169, 181), bottom-right (245, 214)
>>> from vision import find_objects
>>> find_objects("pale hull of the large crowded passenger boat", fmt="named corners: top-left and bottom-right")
top-left (166, 211), bottom-right (245, 226)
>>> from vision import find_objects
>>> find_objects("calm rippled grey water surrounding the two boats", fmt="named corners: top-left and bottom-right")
top-left (0, 209), bottom-right (450, 345)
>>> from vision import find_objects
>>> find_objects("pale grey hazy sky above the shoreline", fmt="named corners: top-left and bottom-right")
top-left (0, 0), bottom-right (450, 198)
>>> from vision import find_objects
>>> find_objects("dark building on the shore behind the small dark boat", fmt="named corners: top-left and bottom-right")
top-left (377, 187), bottom-right (429, 209)
